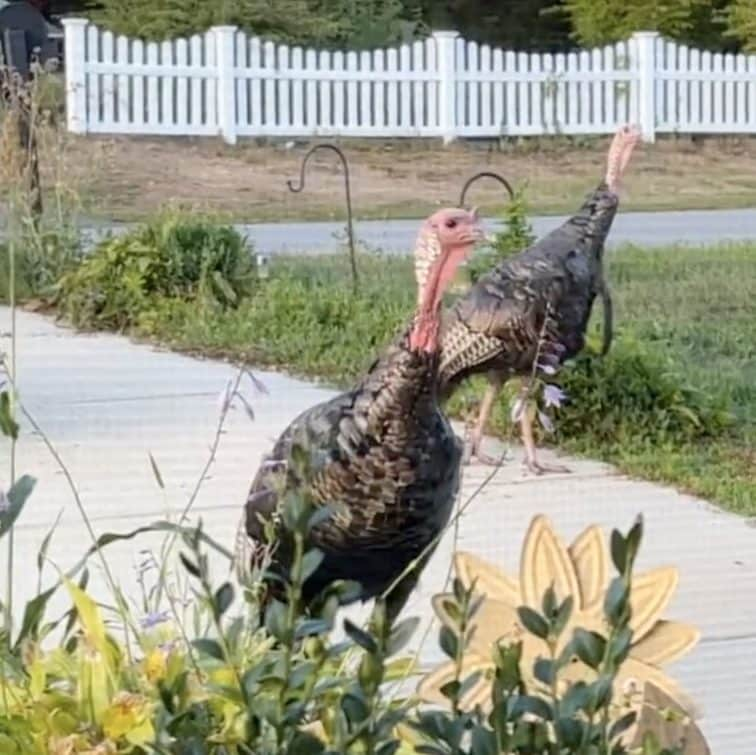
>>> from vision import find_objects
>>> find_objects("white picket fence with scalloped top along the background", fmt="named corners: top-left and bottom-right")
top-left (64, 19), bottom-right (756, 143)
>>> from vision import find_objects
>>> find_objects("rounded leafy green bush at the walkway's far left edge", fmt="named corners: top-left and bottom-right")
top-left (58, 212), bottom-right (255, 330)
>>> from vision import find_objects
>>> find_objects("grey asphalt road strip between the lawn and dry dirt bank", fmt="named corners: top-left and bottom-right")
top-left (239, 209), bottom-right (756, 254)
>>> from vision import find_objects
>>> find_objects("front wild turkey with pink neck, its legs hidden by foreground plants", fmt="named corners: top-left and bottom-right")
top-left (237, 209), bottom-right (482, 620)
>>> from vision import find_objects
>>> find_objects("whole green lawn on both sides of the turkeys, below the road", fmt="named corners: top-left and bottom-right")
top-left (115, 245), bottom-right (756, 514)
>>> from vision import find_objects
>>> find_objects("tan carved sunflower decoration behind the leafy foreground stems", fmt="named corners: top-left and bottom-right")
top-left (418, 516), bottom-right (708, 754)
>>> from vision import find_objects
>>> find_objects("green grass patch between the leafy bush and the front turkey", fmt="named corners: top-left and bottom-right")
top-left (140, 255), bottom-right (415, 384)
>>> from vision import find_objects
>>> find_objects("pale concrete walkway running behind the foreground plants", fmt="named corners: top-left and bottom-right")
top-left (0, 308), bottom-right (756, 755)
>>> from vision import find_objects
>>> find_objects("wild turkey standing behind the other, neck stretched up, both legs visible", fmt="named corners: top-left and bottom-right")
top-left (439, 127), bottom-right (639, 474)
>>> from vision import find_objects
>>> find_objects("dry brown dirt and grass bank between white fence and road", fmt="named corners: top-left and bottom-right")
top-left (39, 131), bottom-right (756, 221)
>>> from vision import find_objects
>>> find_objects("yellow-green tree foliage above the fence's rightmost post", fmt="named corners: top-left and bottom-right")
top-left (559, 0), bottom-right (710, 47)
